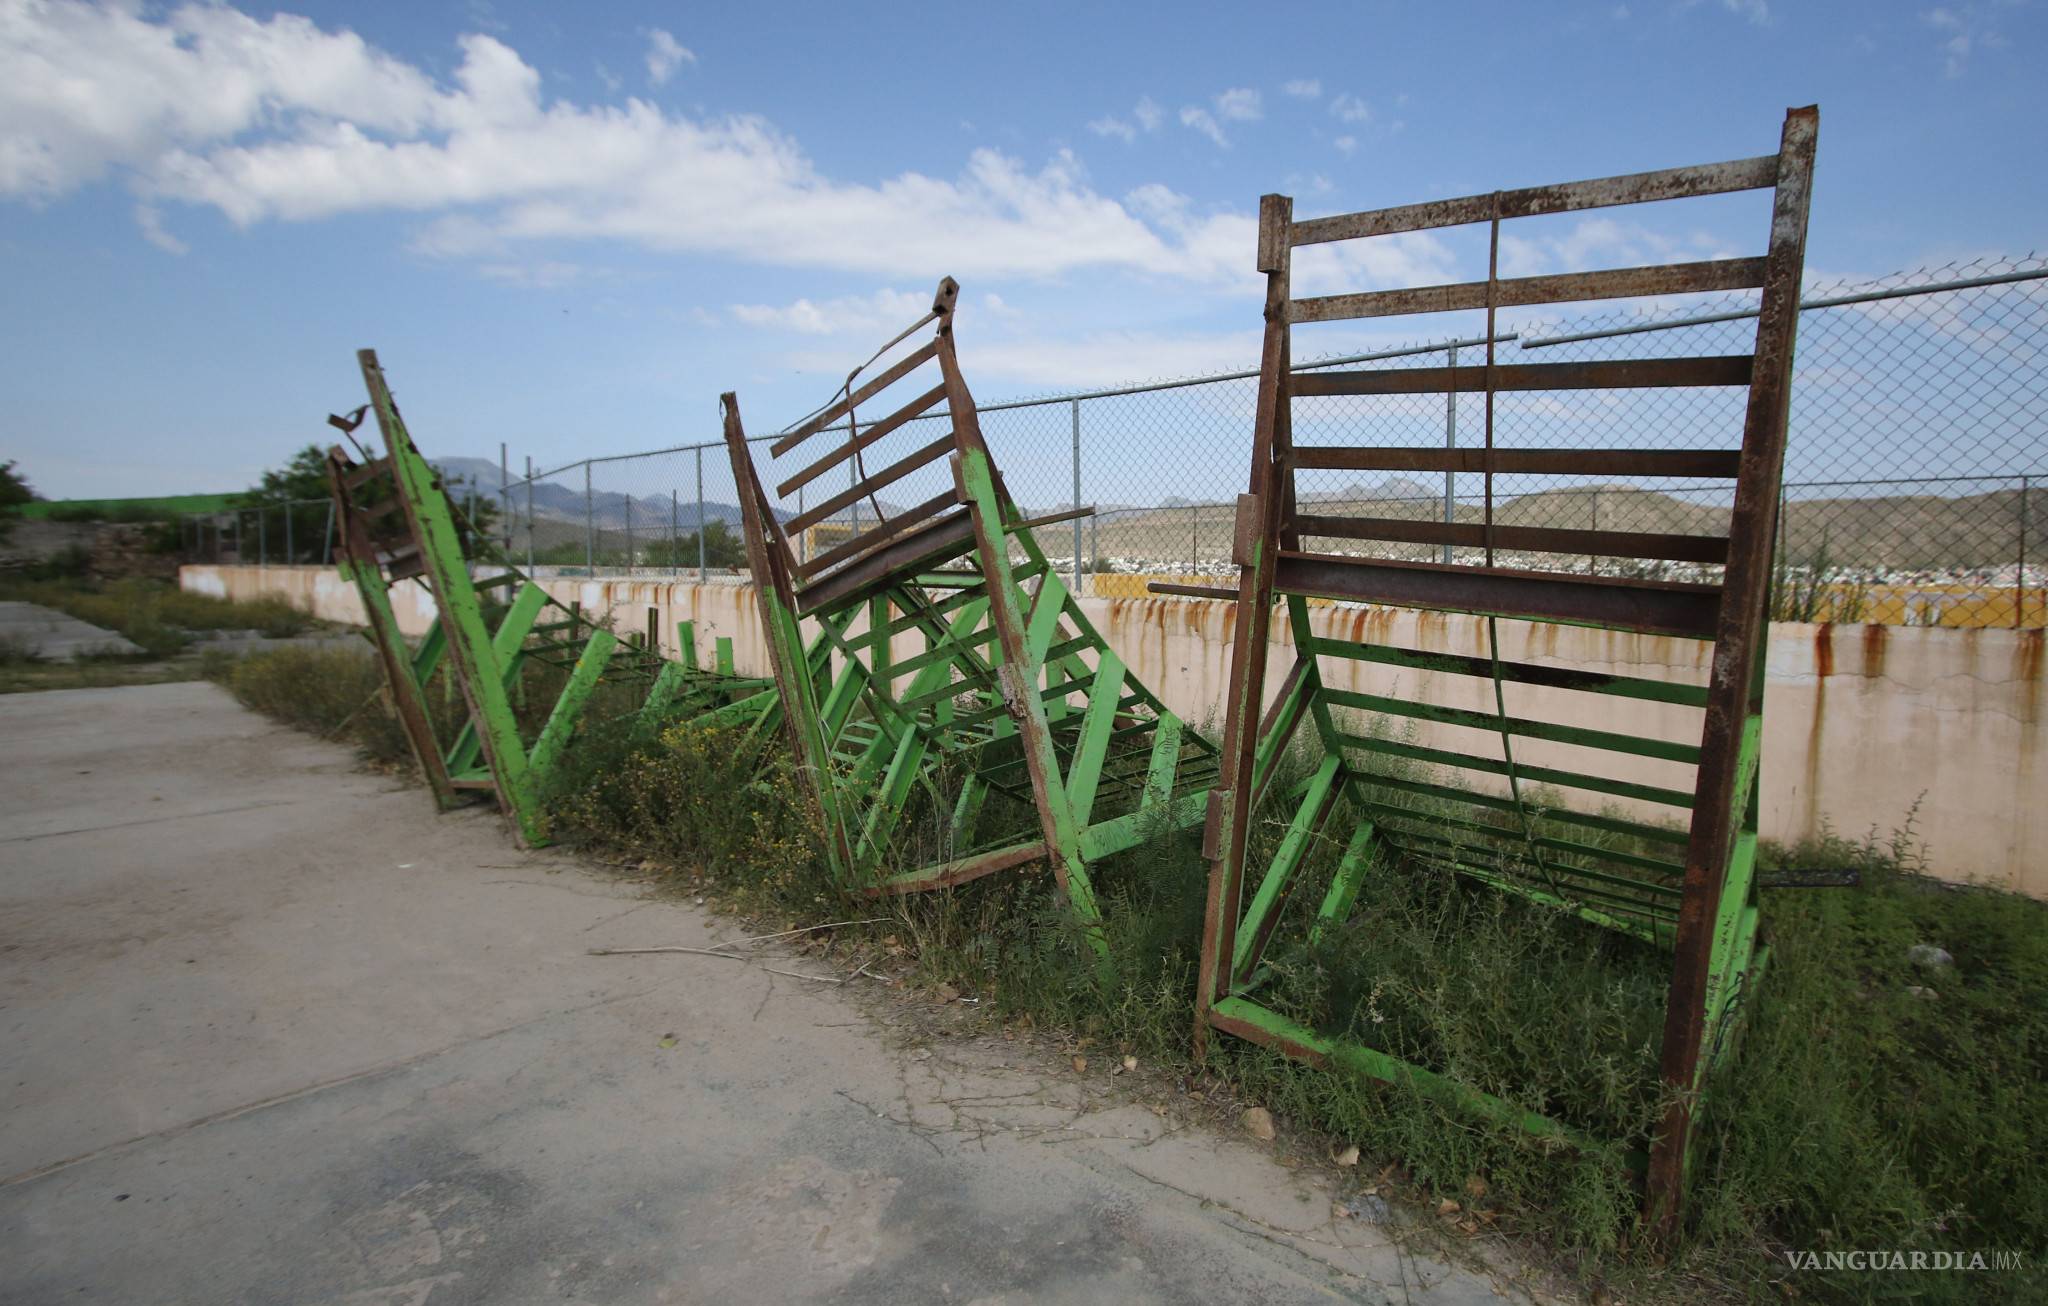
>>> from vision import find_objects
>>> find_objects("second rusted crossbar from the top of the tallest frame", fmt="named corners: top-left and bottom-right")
top-left (1288, 258), bottom-right (1763, 323)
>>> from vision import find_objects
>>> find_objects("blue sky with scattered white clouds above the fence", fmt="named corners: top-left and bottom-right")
top-left (0, 0), bottom-right (2048, 495)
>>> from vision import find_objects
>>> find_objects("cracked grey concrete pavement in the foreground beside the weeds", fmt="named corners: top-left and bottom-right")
top-left (0, 684), bottom-right (1522, 1306)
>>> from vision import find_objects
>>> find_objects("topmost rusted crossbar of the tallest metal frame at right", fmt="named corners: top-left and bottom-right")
top-left (1294, 156), bottom-right (1778, 245)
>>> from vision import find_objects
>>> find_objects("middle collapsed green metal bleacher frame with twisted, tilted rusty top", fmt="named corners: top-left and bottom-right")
top-left (723, 278), bottom-right (1217, 952)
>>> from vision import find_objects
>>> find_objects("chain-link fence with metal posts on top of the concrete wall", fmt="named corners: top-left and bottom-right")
top-left (193, 256), bottom-right (2048, 626)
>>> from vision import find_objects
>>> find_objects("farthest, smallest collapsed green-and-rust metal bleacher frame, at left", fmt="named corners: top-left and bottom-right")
top-left (328, 350), bottom-right (780, 845)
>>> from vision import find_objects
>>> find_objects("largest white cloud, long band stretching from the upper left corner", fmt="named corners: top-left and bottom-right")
top-left (0, 0), bottom-right (1253, 282)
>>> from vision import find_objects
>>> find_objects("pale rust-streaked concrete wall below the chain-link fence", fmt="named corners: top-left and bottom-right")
top-left (182, 567), bottom-right (2048, 899)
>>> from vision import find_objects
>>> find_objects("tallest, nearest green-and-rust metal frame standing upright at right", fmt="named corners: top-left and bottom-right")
top-left (1196, 108), bottom-right (1819, 1230)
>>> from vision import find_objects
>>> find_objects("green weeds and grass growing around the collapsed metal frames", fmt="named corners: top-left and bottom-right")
top-left (207, 651), bottom-right (2048, 1302)
